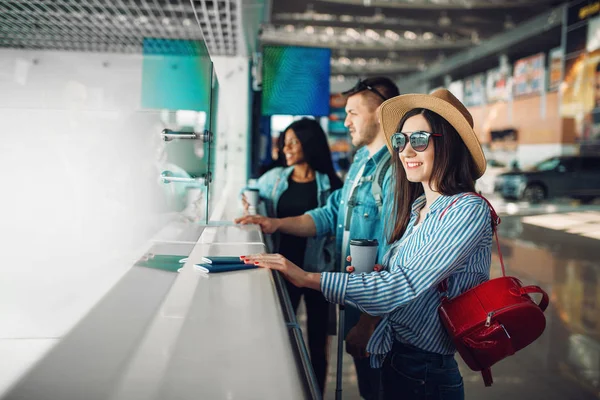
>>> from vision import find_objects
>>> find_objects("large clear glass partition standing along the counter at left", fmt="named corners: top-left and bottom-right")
top-left (0, 1), bottom-right (217, 393)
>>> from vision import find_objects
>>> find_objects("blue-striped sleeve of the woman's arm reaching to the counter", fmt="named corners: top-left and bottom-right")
top-left (321, 199), bottom-right (491, 315)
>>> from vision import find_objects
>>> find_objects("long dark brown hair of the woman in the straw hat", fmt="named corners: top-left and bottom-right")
top-left (388, 108), bottom-right (477, 243)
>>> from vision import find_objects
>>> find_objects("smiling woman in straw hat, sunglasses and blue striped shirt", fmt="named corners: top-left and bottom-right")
top-left (244, 89), bottom-right (492, 400)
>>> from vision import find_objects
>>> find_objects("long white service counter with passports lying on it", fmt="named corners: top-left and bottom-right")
top-left (3, 206), bottom-right (320, 400)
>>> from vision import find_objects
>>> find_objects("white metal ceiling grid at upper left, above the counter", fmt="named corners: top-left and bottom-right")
top-left (0, 0), bottom-right (239, 55)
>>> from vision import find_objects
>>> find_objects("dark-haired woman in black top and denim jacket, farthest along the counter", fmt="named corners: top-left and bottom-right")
top-left (240, 118), bottom-right (342, 391)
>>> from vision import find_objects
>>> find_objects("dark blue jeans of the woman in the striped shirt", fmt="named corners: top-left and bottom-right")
top-left (382, 342), bottom-right (465, 400)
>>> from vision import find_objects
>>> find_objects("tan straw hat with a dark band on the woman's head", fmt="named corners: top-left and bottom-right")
top-left (378, 89), bottom-right (486, 179)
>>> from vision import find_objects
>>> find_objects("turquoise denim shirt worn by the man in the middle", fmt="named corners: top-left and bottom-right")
top-left (307, 146), bottom-right (394, 271)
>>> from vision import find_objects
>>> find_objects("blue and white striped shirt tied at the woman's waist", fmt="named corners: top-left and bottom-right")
top-left (321, 194), bottom-right (492, 368)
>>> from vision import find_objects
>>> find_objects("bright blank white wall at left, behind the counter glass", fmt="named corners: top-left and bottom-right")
top-left (0, 50), bottom-right (192, 393)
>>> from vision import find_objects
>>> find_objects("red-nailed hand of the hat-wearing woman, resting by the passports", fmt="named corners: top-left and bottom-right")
top-left (240, 254), bottom-right (321, 291)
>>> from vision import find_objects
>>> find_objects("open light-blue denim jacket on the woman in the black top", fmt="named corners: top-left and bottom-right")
top-left (246, 167), bottom-right (337, 272)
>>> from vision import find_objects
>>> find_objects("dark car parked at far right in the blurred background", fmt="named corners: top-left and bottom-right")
top-left (495, 155), bottom-right (600, 203)
